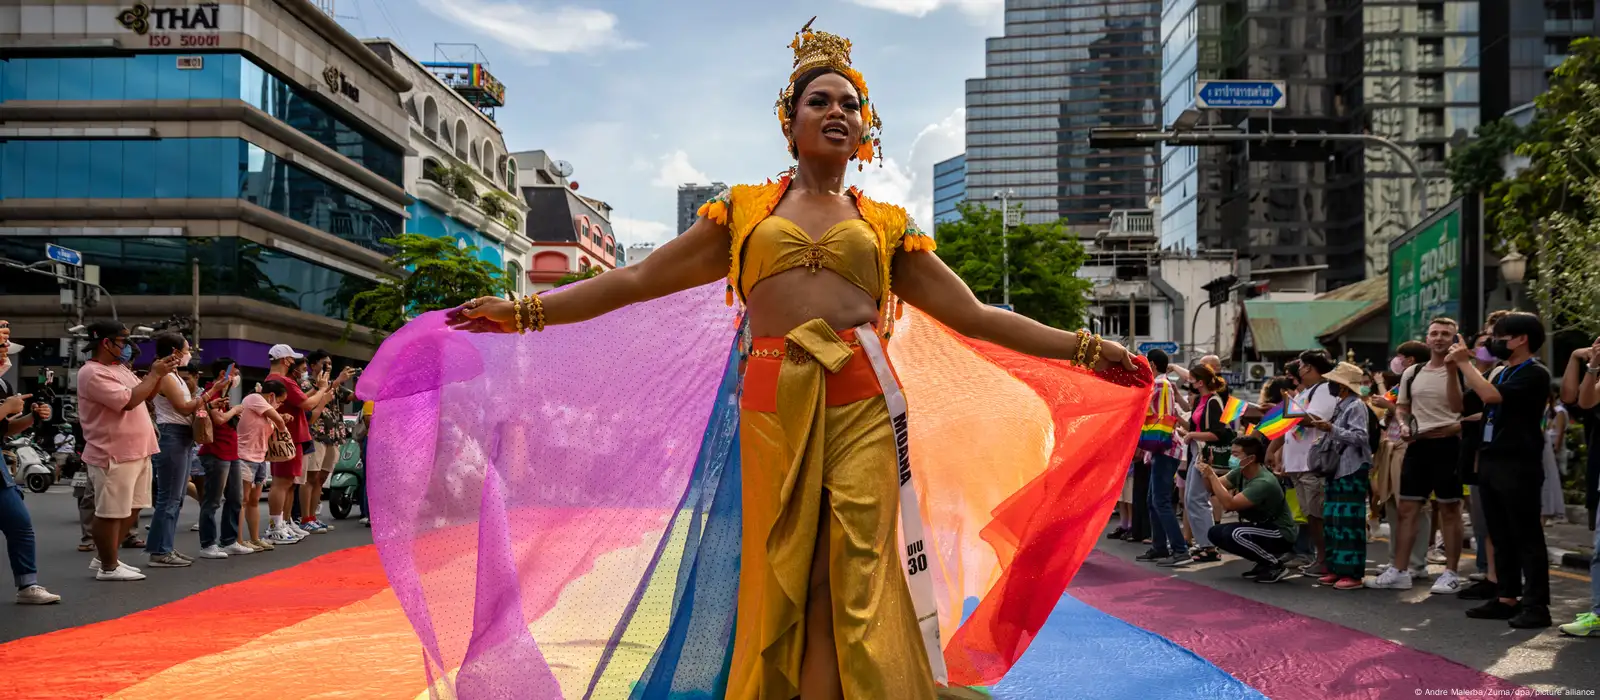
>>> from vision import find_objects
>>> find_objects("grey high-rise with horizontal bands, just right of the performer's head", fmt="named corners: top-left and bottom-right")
top-left (966, 0), bottom-right (1162, 229)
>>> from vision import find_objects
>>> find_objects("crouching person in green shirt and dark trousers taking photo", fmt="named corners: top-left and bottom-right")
top-left (1195, 435), bottom-right (1299, 583)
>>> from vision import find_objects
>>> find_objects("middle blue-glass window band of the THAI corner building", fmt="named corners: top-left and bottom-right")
top-left (0, 139), bottom-right (403, 254)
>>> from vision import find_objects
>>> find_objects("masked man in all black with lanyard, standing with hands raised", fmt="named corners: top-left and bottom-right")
top-left (1450, 312), bottom-right (1550, 630)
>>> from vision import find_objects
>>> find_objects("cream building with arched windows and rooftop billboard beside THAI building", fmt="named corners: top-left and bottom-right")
top-left (366, 38), bottom-right (533, 292)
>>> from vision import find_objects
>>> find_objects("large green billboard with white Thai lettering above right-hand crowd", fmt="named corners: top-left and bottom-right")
top-left (1389, 208), bottom-right (1461, 345)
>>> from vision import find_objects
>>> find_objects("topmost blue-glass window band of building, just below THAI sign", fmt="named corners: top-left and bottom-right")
top-left (0, 54), bottom-right (405, 184)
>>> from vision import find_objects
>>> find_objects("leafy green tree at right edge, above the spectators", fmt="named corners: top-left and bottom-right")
top-left (1448, 38), bottom-right (1600, 332)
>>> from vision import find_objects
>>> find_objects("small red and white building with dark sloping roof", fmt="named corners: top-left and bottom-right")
top-left (524, 150), bottom-right (618, 291)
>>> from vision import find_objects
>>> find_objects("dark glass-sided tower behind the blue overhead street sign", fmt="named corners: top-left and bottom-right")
top-left (1162, 0), bottom-right (1366, 286)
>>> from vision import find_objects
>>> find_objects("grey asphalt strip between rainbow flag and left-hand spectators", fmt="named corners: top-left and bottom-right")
top-left (0, 484), bottom-right (373, 642)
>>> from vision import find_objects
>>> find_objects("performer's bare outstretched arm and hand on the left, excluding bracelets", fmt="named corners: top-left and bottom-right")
top-left (450, 217), bottom-right (731, 332)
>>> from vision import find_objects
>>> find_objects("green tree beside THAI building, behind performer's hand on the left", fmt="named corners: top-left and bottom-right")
top-left (350, 233), bottom-right (509, 332)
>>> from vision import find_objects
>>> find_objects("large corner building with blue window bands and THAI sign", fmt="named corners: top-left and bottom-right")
top-left (0, 0), bottom-right (413, 369)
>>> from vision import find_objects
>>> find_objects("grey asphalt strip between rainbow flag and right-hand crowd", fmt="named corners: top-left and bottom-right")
top-left (1099, 524), bottom-right (1600, 697)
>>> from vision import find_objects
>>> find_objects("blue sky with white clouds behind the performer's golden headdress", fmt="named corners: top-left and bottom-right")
top-left (334, 0), bottom-right (1003, 249)
